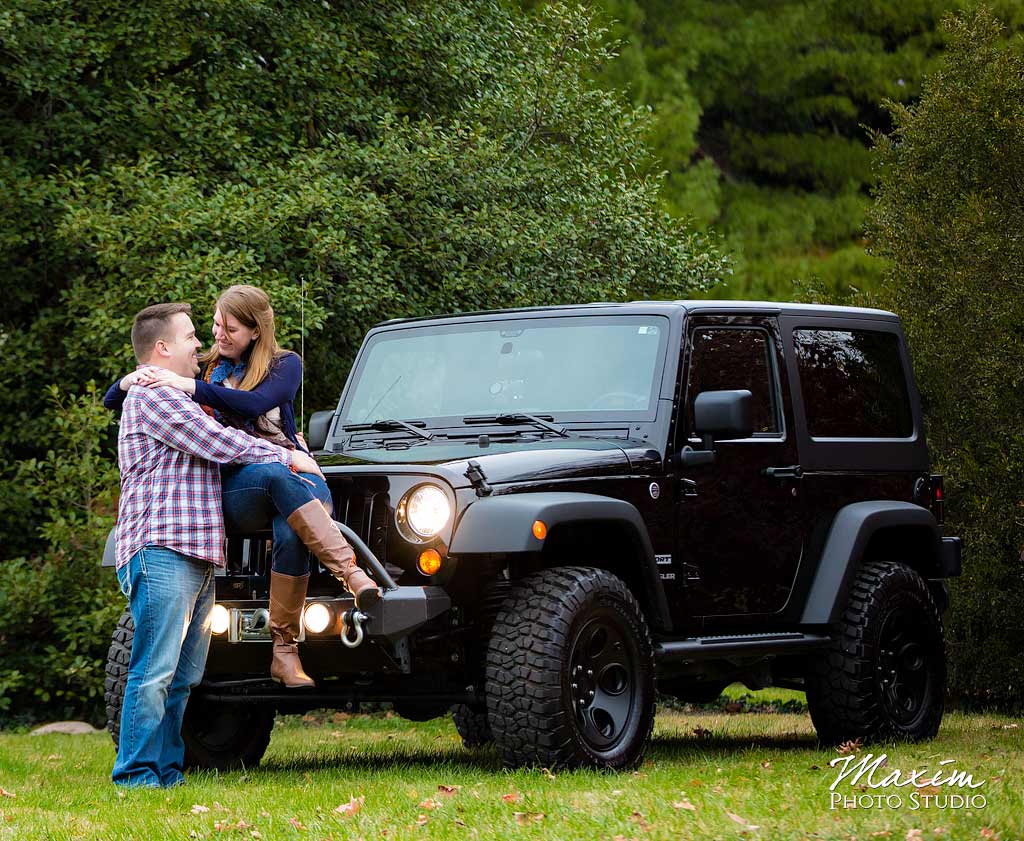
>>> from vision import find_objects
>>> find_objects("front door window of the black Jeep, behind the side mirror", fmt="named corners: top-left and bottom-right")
top-left (687, 327), bottom-right (782, 436)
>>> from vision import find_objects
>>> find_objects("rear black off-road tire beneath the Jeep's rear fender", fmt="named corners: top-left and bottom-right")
top-left (806, 561), bottom-right (946, 745)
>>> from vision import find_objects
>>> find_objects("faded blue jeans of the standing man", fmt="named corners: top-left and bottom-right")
top-left (113, 546), bottom-right (214, 787)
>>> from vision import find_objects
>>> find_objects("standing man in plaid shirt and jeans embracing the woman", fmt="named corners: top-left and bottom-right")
top-left (113, 303), bottom-right (318, 787)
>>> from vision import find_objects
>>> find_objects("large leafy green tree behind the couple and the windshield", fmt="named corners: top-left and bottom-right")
top-left (0, 0), bottom-right (725, 713)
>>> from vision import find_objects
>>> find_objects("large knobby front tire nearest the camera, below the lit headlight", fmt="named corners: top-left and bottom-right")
top-left (485, 566), bottom-right (654, 769)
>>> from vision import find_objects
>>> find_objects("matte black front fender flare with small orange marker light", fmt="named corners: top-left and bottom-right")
top-left (449, 492), bottom-right (672, 630)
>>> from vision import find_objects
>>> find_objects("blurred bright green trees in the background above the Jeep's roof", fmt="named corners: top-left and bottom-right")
top-left (585, 0), bottom-right (1024, 302)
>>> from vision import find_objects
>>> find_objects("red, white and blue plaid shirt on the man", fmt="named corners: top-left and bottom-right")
top-left (117, 385), bottom-right (290, 567)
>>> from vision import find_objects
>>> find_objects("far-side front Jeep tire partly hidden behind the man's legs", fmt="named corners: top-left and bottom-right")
top-left (103, 611), bottom-right (274, 771)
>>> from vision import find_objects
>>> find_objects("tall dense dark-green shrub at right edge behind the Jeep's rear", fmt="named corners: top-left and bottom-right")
top-left (871, 12), bottom-right (1024, 708)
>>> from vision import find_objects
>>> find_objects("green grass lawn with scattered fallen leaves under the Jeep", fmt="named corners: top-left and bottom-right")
top-left (0, 688), bottom-right (1024, 841)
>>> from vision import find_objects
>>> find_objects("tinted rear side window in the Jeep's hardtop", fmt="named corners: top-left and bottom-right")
top-left (793, 329), bottom-right (913, 438)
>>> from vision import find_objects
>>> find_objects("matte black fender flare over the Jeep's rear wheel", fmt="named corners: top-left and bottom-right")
top-left (801, 500), bottom-right (961, 625)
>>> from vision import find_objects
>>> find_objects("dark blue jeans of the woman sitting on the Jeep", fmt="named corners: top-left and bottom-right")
top-left (220, 464), bottom-right (332, 576)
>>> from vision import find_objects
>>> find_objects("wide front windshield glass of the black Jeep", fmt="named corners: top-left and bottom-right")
top-left (341, 316), bottom-right (669, 432)
